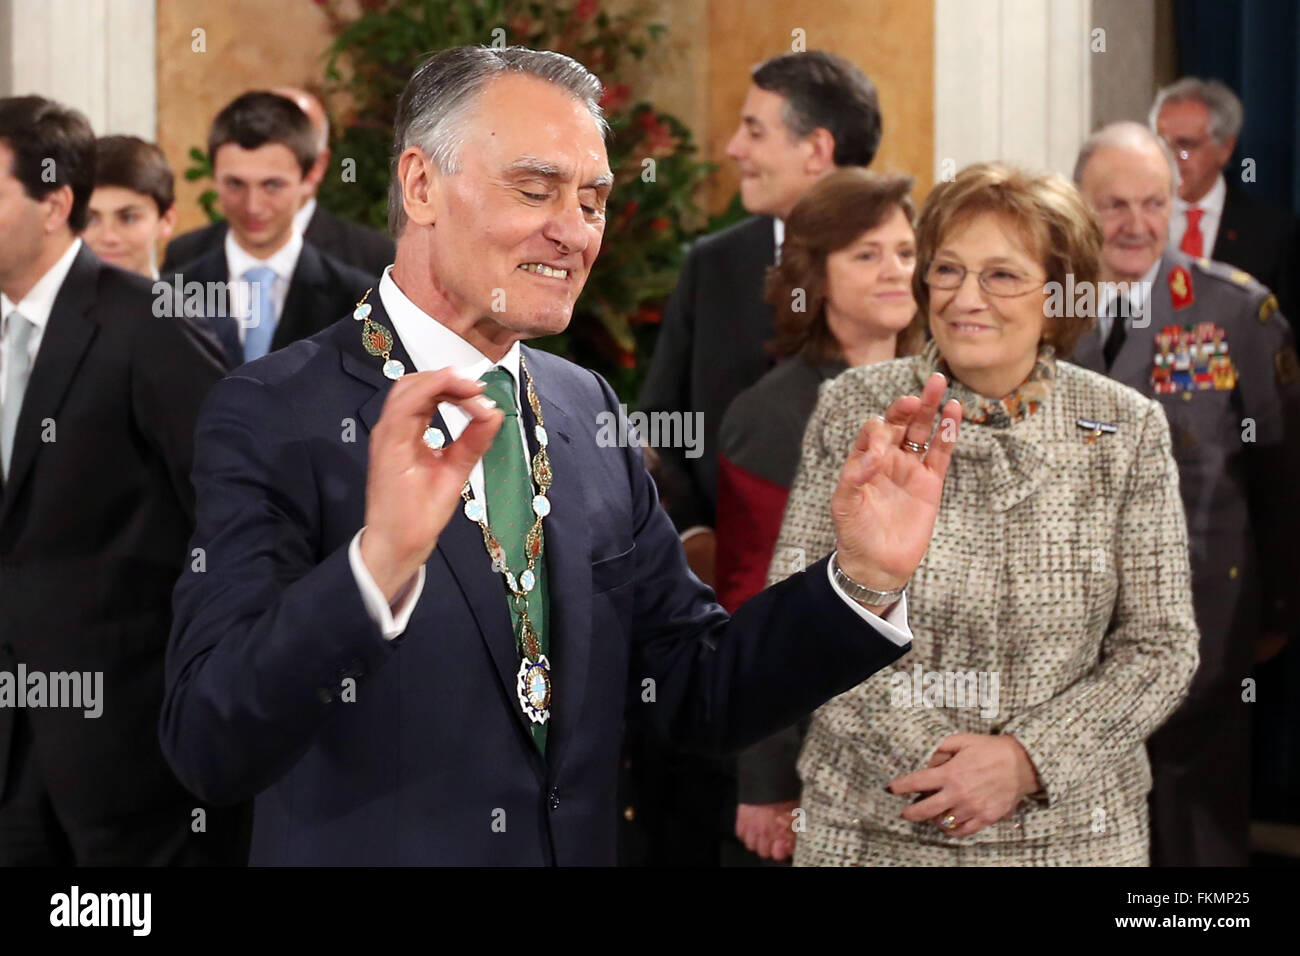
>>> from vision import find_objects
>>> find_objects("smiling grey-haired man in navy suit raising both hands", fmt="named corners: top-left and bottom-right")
top-left (161, 47), bottom-right (961, 865)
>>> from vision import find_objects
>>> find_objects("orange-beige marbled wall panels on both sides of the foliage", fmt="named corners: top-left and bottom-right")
top-left (157, 0), bottom-right (933, 230)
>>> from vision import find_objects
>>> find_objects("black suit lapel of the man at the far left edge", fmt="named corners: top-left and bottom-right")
top-left (0, 245), bottom-right (101, 520)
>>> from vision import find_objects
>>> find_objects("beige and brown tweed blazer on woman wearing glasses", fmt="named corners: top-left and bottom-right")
top-left (768, 343), bottom-right (1197, 865)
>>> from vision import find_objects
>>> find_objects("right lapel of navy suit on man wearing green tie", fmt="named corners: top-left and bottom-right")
top-left (521, 347), bottom-right (592, 769)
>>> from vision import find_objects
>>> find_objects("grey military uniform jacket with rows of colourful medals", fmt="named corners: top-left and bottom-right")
top-left (1074, 250), bottom-right (1300, 709)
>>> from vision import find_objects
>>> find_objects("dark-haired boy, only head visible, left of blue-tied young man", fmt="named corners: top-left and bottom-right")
top-left (82, 137), bottom-right (176, 278)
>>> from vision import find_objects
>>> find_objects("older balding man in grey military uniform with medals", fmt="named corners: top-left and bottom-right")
top-left (1071, 124), bottom-right (1300, 866)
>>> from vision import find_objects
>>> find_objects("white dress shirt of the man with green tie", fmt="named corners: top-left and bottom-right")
top-left (347, 265), bottom-right (911, 646)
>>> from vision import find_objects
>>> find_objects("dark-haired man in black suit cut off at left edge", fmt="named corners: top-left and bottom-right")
top-left (0, 96), bottom-right (242, 866)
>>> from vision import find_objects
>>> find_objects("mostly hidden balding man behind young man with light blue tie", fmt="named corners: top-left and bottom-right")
top-left (163, 86), bottom-right (394, 280)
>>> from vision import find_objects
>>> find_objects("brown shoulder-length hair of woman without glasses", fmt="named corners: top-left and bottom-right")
top-left (764, 168), bottom-right (926, 362)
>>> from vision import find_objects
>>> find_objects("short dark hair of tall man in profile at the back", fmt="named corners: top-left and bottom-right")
top-left (753, 49), bottom-right (881, 166)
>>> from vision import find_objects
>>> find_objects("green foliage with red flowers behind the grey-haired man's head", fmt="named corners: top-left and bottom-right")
top-left (186, 0), bottom-right (744, 401)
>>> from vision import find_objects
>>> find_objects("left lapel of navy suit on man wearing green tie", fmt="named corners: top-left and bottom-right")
top-left (342, 294), bottom-right (535, 749)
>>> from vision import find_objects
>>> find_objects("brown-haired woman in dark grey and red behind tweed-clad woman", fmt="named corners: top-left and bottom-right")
top-left (716, 168), bottom-right (924, 860)
